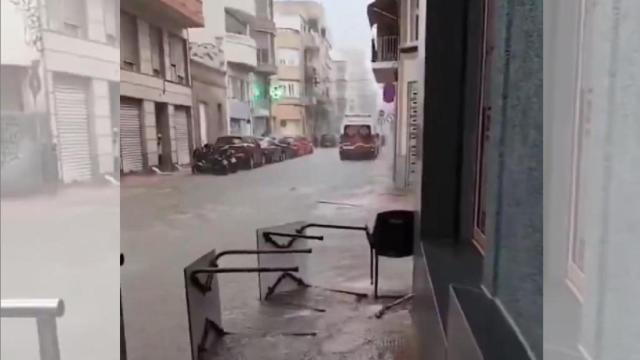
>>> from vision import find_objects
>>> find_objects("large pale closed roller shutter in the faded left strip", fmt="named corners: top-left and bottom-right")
top-left (54, 79), bottom-right (93, 183)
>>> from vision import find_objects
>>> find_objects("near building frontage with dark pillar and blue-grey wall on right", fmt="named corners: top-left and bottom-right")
top-left (367, 0), bottom-right (543, 360)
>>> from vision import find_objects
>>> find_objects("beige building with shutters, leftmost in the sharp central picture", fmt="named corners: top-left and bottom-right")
top-left (119, 0), bottom-right (204, 173)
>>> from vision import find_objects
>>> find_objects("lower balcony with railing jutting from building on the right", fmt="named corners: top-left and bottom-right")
top-left (371, 35), bottom-right (399, 84)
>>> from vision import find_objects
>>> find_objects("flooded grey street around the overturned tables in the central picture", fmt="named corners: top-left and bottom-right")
top-left (121, 147), bottom-right (412, 360)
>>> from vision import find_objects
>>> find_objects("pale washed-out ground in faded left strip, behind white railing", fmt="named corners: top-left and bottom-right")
top-left (1, 186), bottom-right (120, 360)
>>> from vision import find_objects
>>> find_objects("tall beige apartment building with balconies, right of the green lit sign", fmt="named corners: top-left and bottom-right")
top-left (274, 1), bottom-right (333, 137)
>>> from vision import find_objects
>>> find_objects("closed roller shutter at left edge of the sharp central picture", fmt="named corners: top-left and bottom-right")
top-left (120, 98), bottom-right (144, 174)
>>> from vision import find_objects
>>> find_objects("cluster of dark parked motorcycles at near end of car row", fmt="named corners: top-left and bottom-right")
top-left (191, 144), bottom-right (238, 175)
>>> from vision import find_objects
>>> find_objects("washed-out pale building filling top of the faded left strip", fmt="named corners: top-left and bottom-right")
top-left (2, 0), bottom-right (119, 186)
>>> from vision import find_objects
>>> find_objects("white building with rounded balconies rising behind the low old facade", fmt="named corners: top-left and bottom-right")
top-left (189, 0), bottom-right (258, 135)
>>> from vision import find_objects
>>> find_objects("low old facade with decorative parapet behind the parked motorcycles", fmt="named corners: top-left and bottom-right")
top-left (190, 42), bottom-right (229, 147)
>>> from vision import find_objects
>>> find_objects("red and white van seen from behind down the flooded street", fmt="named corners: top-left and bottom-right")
top-left (339, 114), bottom-right (380, 160)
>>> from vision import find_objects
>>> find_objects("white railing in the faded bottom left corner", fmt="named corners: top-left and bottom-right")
top-left (0, 299), bottom-right (64, 360)
